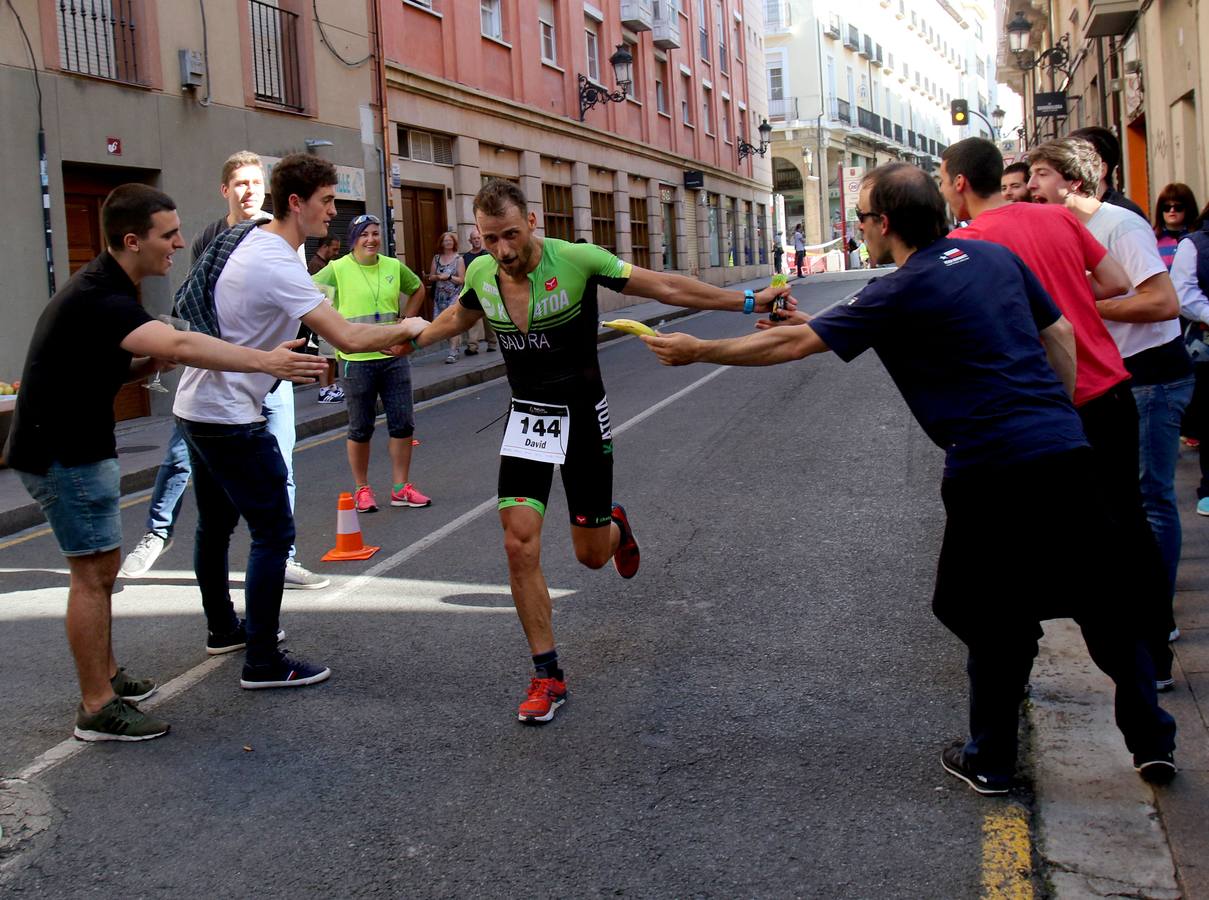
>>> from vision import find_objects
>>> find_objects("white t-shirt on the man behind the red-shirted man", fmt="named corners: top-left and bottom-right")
top-left (1087, 203), bottom-right (1180, 359)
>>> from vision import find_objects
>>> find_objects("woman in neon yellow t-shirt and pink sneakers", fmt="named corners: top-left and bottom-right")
top-left (314, 215), bottom-right (432, 513)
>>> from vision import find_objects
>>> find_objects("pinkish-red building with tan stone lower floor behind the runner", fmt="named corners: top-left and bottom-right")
top-left (382, 0), bottom-right (770, 295)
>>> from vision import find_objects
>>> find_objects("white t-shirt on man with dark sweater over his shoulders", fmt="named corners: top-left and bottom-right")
top-left (172, 227), bottom-right (324, 425)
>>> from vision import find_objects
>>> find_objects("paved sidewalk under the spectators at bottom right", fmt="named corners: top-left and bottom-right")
top-left (1029, 449), bottom-right (1209, 900)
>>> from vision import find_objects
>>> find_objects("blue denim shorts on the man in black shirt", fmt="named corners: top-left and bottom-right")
top-left (17, 460), bottom-right (122, 556)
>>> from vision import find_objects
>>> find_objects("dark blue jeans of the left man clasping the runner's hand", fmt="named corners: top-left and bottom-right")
top-left (178, 419), bottom-right (294, 665)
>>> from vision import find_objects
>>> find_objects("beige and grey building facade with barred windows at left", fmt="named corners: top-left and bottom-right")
top-left (0, 0), bottom-right (383, 417)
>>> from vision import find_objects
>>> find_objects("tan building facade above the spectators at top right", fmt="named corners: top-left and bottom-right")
top-left (999, 0), bottom-right (1209, 214)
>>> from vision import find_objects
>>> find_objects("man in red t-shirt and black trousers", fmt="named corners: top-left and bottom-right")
top-left (941, 138), bottom-right (1170, 691)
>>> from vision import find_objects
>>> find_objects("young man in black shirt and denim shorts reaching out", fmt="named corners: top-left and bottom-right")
top-left (5, 184), bottom-right (323, 740)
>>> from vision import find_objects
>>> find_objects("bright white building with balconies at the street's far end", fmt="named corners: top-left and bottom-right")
top-left (764, 0), bottom-right (996, 244)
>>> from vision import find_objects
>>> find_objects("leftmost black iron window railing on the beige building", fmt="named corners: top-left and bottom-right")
top-left (56, 0), bottom-right (143, 85)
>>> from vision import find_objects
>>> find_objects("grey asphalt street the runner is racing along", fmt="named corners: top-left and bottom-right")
top-left (0, 283), bottom-right (1020, 898)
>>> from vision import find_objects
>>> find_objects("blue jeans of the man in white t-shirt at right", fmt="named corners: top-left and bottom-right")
top-left (1133, 375), bottom-right (1194, 596)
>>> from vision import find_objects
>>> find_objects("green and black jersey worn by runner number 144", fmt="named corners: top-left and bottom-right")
top-left (458, 237), bottom-right (632, 403)
